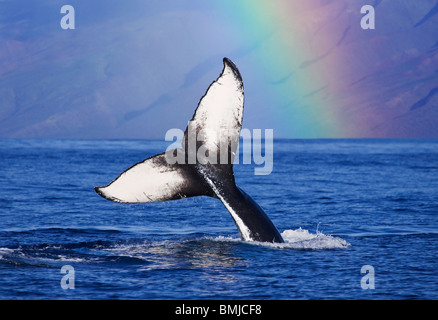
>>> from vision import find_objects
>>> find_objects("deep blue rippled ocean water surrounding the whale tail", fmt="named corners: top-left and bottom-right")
top-left (0, 139), bottom-right (438, 299)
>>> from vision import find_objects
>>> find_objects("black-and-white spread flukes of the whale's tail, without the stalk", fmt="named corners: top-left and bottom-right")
top-left (94, 58), bottom-right (243, 203)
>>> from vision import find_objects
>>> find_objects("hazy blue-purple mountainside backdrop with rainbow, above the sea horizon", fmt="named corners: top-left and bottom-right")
top-left (0, 0), bottom-right (438, 139)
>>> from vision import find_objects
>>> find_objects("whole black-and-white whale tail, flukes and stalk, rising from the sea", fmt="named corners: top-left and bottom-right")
top-left (94, 58), bottom-right (283, 242)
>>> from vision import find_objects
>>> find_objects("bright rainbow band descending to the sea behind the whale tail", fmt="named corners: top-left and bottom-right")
top-left (210, 0), bottom-right (368, 138)
